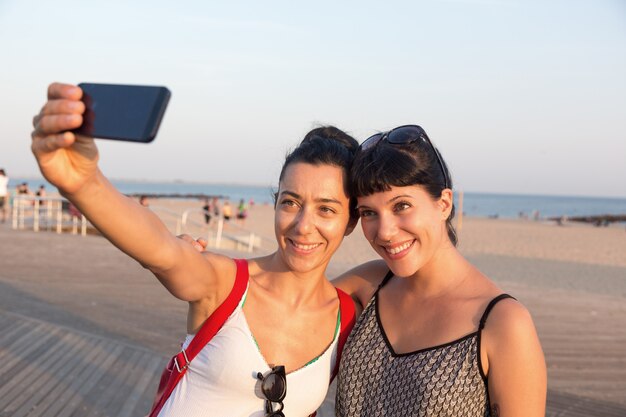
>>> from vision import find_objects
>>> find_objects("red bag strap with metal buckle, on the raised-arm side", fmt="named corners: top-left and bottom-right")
top-left (149, 259), bottom-right (249, 417)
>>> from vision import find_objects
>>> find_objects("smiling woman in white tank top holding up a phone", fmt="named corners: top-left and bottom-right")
top-left (32, 84), bottom-right (358, 417)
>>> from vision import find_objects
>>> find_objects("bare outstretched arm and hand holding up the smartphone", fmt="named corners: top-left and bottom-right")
top-left (31, 83), bottom-right (232, 301)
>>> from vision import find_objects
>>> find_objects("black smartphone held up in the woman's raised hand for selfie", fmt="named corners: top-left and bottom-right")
top-left (74, 83), bottom-right (171, 143)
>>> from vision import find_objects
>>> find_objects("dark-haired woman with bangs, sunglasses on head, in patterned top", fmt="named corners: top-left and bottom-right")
top-left (333, 125), bottom-right (546, 417)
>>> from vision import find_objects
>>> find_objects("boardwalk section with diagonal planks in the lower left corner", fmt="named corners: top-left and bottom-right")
top-left (0, 310), bottom-right (165, 417)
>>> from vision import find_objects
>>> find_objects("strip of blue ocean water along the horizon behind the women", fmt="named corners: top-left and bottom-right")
top-left (9, 178), bottom-right (626, 218)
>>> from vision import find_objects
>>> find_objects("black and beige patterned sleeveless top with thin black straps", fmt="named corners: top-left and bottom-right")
top-left (335, 277), bottom-right (512, 417)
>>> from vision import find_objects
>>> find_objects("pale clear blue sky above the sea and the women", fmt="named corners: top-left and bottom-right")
top-left (0, 0), bottom-right (626, 197)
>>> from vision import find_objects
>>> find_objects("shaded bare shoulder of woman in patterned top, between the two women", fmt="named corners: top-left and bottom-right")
top-left (332, 260), bottom-right (389, 309)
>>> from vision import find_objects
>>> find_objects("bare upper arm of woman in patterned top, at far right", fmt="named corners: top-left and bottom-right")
top-left (483, 300), bottom-right (547, 417)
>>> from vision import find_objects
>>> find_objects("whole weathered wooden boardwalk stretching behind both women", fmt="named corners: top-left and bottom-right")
top-left (0, 225), bottom-right (626, 417)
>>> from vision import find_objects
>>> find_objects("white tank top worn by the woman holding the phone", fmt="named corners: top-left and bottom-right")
top-left (159, 289), bottom-right (339, 417)
